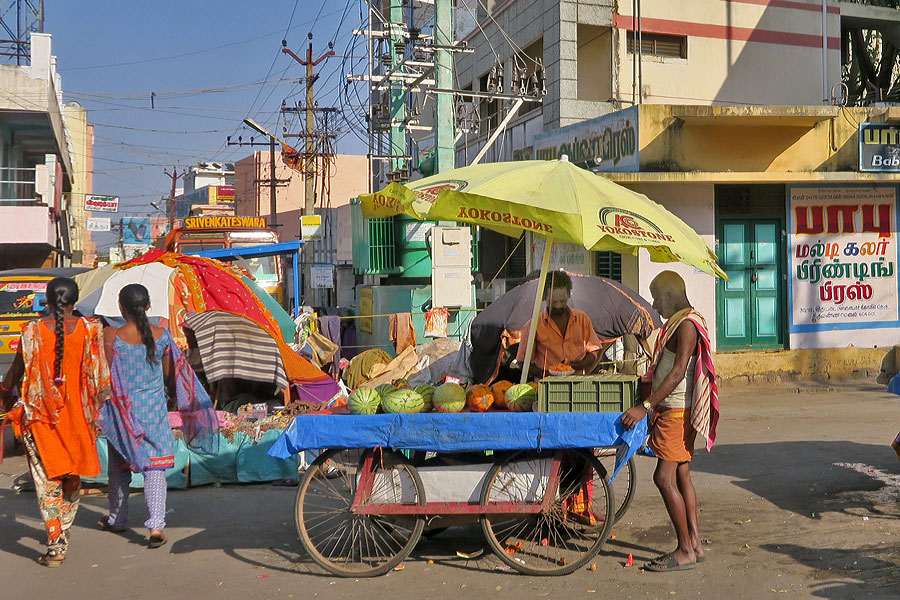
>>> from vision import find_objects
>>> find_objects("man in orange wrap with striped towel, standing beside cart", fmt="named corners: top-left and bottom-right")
top-left (622, 271), bottom-right (719, 572)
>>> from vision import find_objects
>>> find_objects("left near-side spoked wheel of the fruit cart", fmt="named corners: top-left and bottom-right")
top-left (294, 449), bottom-right (425, 577)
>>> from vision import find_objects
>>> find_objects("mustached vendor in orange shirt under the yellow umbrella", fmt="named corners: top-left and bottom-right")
top-left (516, 271), bottom-right (602, 378)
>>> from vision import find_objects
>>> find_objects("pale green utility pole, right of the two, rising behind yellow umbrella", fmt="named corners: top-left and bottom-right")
top-left (434, 0), bottom-right (456, 173)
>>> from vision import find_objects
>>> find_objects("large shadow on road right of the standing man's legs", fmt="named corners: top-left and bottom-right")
top-left (691, 441), bottom-right (900, 519)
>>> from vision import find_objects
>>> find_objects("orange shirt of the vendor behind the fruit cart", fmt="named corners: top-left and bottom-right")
top-left (516, 308), bottom-right (601, 371)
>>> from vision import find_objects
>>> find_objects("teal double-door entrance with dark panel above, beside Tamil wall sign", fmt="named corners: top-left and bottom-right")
top-left (716, 185), bottom-right (786, 350)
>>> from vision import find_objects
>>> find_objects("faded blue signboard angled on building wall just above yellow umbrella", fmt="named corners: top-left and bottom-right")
top-left (534, 106), bottom-right (640, 172)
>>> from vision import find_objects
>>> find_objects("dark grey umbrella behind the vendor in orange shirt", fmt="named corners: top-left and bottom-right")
top-left (469, 273), bottom-right (662, 383)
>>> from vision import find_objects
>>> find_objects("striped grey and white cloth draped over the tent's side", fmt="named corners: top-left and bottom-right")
top-left (184, 310), bottom-right (288, 389)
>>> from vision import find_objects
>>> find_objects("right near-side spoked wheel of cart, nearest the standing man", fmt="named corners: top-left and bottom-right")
top-left (481, 450), bottom-right (614, 575)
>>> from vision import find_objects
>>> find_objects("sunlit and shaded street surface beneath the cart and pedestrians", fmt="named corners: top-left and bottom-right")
top-left (0, 382), bottom-right (900, 600)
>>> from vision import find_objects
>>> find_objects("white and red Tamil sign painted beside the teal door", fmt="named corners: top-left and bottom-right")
top-left (787, 185), bottom-right (900, 333)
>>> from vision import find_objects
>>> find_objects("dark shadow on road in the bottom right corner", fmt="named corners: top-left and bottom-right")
top-left (761, 544), bottom-right (900, 600)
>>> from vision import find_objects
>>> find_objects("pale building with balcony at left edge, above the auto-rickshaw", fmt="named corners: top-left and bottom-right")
top-left (0, 33), bottom-right (75, 269)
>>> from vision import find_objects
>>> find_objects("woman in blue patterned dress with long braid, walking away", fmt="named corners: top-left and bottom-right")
top-left (97, 283), bottom-right (218, 548)
